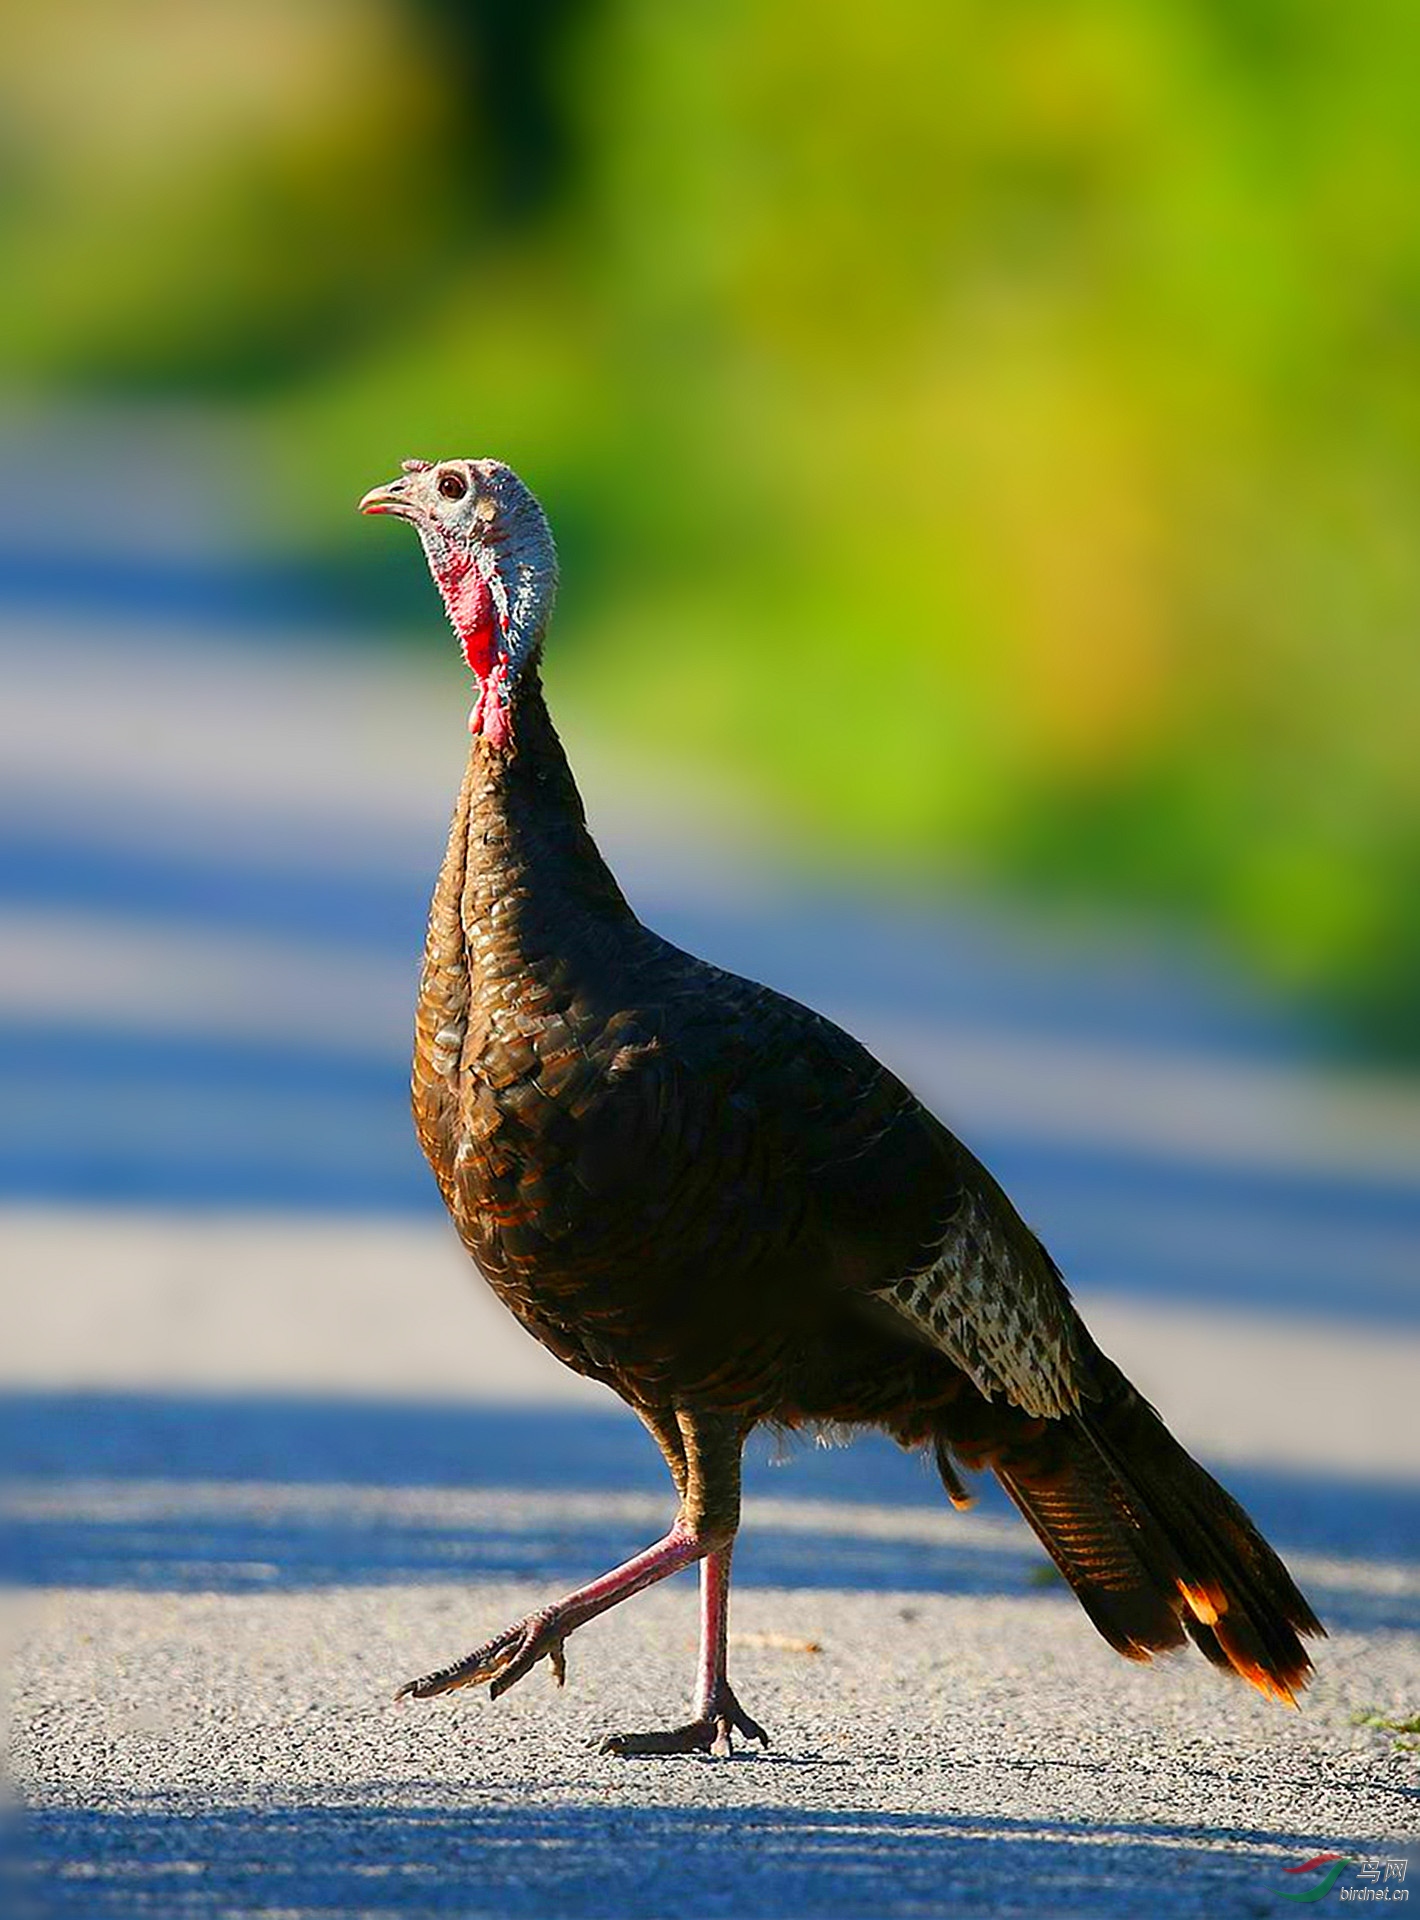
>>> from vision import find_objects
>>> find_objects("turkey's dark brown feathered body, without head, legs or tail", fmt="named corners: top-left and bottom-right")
top-left (414, 675), bottom-right (1051, 1425)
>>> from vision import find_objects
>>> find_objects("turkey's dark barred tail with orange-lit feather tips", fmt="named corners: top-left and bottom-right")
top-left (948, 1356), bottom-right (1326, 1705)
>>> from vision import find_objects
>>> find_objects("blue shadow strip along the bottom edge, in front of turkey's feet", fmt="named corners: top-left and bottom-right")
top-left (8, 1797), bottom-right (1403, 1920)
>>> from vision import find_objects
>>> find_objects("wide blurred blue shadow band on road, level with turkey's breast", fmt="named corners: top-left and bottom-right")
top-left (0, 1012), bottom-right (1420, 1329)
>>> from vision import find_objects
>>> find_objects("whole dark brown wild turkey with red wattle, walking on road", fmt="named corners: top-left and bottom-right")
top-left (361, 459), bottom-right (1322, 1753)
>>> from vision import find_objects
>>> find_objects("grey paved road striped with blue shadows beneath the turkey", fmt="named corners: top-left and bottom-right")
top-left (0, 487), bottom-right (1420, 1916)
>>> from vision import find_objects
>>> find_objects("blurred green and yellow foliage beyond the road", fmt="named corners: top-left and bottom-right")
top-left (0, 0), bottom-right (1420, 1050)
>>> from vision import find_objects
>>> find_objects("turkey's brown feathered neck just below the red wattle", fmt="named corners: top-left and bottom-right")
top-left (430, 664), bottom-right (637, 1000)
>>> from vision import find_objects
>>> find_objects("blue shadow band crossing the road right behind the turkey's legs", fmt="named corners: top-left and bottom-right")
top-left (0, 1392), bottom-right (1420, 1632)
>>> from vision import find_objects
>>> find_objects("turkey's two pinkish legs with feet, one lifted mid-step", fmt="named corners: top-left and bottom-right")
top-left (395, 1409), bottom-right (769, 1753)
